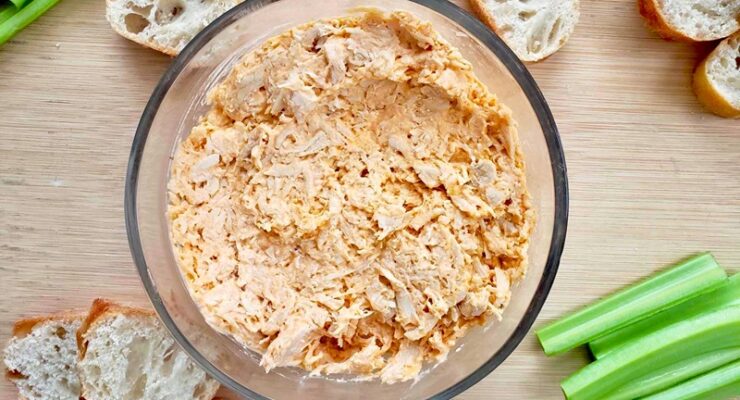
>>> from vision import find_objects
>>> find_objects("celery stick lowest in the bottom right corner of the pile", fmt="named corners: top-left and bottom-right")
top-left (645, 360), bottom-right (740, 400)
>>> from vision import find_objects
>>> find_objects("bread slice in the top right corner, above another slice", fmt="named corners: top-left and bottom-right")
top-left (638, 0), bottom-right (740, 42)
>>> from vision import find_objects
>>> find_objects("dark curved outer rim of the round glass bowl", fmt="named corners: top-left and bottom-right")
top-left (124, 0), bottom-right (569, 399)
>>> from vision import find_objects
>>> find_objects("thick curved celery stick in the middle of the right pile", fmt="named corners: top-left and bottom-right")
top-left (560, 306), bottom-right (740, 400)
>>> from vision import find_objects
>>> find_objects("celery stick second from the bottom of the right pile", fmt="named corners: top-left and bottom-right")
top-left (603, 347), bottom-right (740, 400)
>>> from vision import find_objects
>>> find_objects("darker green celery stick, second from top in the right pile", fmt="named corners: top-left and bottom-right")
top-left (588, 274), bottom-right (740, 359)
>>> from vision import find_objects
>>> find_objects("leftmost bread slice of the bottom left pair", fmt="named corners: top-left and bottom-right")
top-left (4, 312), bottom-right (85, 400)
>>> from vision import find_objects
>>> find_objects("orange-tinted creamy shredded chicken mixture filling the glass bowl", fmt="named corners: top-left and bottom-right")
top-left (168, 12), bottom-right (533, 383)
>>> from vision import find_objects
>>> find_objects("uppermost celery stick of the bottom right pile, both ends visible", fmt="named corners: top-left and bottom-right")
top-left (537, 253), bottom-right (727, 355)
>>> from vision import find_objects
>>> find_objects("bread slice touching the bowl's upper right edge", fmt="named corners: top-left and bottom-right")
top-left (470, 0), bottom-right (580, 62)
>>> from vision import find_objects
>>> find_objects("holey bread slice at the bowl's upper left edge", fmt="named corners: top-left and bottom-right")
top-left (105, 0), bottom-right (243, 56)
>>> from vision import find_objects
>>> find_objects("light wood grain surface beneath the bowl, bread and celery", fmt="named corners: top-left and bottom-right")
top-left (0, 0), bottom-right (740, 400)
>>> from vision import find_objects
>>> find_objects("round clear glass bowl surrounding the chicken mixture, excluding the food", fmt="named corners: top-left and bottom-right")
top-left (125, 0), bottom-right (568, 399)
